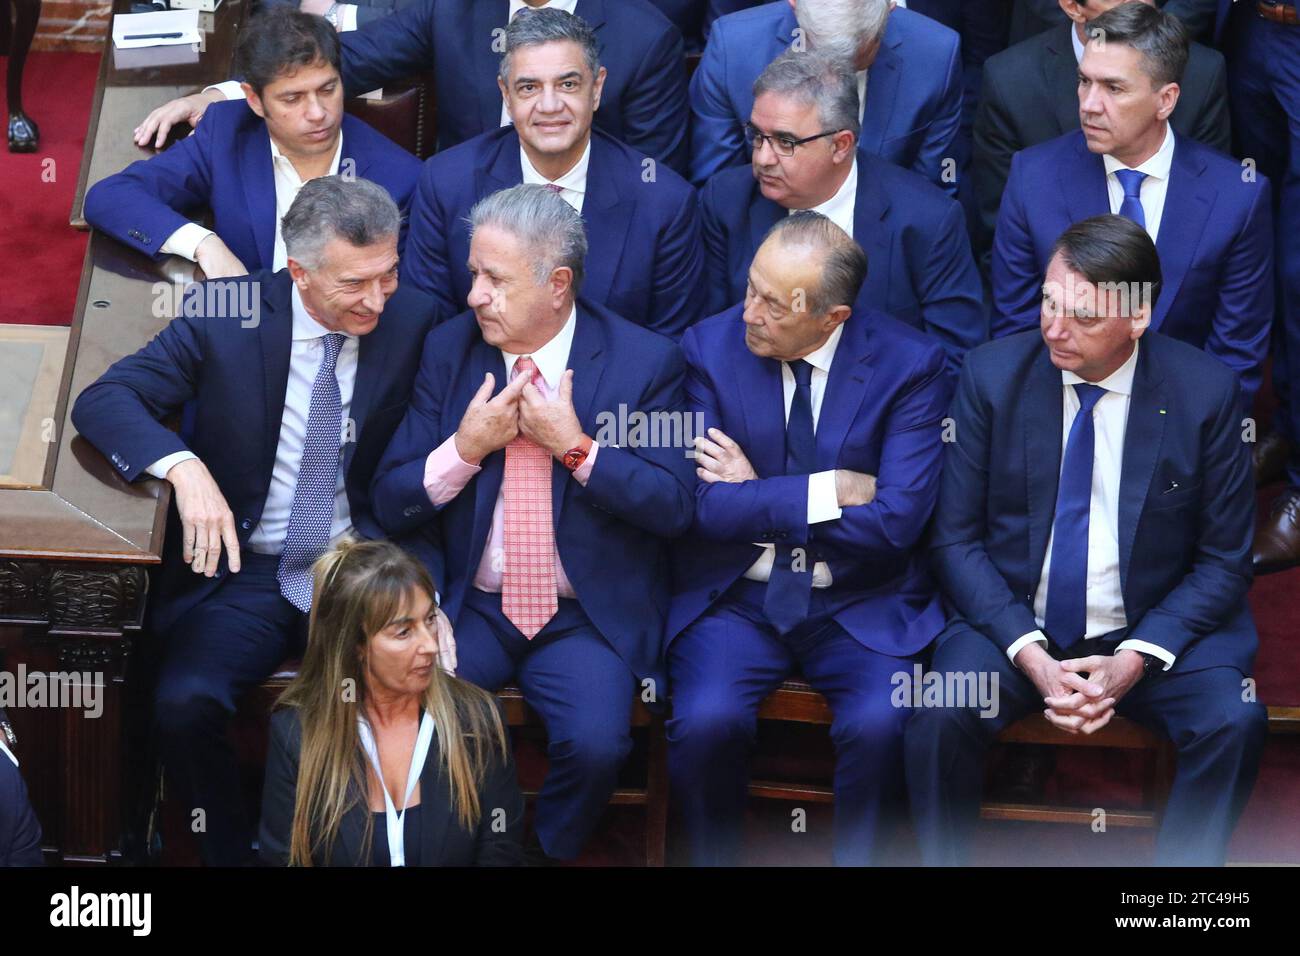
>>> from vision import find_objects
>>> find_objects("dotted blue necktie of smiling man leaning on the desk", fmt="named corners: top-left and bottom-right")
top-left (276, 332), bottom-right (343, 611)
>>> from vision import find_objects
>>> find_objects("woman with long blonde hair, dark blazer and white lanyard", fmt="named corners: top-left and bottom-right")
top-left (259, 541), bottom-right (524, 866)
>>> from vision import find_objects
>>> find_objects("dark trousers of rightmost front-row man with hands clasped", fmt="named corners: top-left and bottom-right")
top-left (906, 624), bottom-right (1268, 866)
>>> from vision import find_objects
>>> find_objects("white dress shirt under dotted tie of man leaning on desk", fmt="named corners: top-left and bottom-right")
top-left (147, 285), bottom-right (360, 554)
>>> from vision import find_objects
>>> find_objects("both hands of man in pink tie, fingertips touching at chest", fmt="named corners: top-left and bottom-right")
top-left (455, 369), bottom-right (582, 464)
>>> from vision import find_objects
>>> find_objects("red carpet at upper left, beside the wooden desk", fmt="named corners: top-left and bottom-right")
top-left (0, 53), bottom-right (99, 325)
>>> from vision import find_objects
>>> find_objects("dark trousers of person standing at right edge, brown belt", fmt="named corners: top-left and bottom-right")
top-left (1225, 3), bottom-right (1300, 489)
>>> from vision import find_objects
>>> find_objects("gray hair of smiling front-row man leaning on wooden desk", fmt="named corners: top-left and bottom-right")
top-left (280, 176), bottom-right (402, 271)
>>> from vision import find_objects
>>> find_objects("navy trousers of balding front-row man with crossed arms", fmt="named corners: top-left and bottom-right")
top-left (667, 580), bottom-right (911, 865)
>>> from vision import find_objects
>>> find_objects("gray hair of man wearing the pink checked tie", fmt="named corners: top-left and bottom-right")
top-left (467, 183), bottom-right (586, 295)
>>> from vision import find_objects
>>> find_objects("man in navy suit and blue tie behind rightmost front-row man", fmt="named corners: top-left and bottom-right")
top-left (992, 3), bottom-right (1273, 403)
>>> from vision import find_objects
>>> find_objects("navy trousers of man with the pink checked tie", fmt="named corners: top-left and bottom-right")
top-left (455, 587), bottom-right (637, 860)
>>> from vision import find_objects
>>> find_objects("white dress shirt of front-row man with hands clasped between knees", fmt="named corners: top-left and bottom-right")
top-left (1006, 343), bottom-right (1174, 670)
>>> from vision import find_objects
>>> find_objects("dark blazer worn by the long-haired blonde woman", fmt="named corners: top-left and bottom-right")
top-left (257, 708), bottom-right (524, 866)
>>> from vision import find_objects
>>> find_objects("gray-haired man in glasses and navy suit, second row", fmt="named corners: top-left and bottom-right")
top-left (701, 51), bottom-right (988, 369)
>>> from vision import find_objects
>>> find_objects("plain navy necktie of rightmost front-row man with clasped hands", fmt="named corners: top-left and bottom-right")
top-left (1043, 384), bottom-right (1106, 649)
